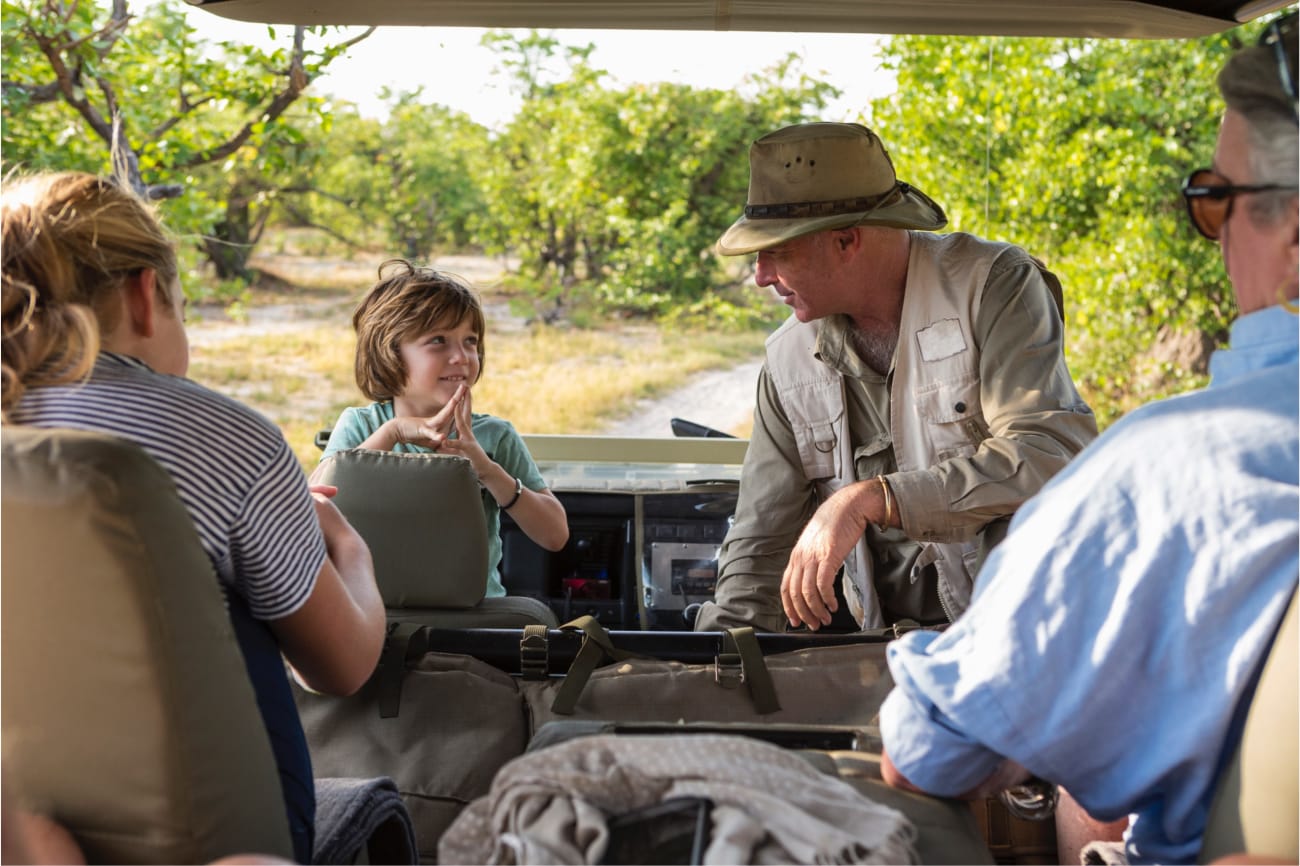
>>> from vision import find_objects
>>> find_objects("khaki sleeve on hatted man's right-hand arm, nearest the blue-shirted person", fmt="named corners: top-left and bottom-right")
top-left (889, 252), bottom-right (1097, 541)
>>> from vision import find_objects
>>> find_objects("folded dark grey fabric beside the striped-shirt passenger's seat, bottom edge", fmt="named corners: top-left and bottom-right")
top-left (312, 776), bottom-right (417, 865)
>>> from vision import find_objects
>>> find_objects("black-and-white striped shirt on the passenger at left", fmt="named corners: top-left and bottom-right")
top-left (12, 352), bottom-right (325, 620)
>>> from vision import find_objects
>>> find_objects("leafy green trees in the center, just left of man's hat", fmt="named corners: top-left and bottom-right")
top-left (478, 34), bottom-right (836, 317)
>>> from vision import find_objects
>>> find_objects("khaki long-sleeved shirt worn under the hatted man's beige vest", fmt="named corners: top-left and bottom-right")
top-left (696, 239), bottom-right (1097, 631)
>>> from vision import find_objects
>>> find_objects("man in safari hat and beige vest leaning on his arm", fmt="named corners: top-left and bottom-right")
top-left (696, 124), bottom-right (1097, 631)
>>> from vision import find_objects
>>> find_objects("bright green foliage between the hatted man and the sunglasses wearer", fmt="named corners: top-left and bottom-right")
top-left (871, 33), bottom-right (1240, 423)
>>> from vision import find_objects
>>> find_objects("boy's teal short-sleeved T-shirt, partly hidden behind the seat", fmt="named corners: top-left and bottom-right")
top-left (321, 400), bottom-right (546, 598)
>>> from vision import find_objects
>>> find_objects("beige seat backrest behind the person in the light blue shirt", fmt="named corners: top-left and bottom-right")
top-left (1200, 596), bottom-right (1300, 863)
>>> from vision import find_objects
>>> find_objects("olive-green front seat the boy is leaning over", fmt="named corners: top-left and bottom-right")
top-left (319, 449), bottom-right (559, 628)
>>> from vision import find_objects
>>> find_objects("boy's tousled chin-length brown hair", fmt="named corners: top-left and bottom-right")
top-left (352, 259), bottom-right (486, 402)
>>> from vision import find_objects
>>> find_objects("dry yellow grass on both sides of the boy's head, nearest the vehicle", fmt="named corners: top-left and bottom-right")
top-left (190, 306), bottom-right (766, 468)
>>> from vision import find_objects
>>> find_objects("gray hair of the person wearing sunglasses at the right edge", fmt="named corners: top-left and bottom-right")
top-left (1218, 38), bottom-right (1300, 225)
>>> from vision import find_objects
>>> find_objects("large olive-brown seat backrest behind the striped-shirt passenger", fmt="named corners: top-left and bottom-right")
top-left (0, 425), bottom-right (293, 863)
